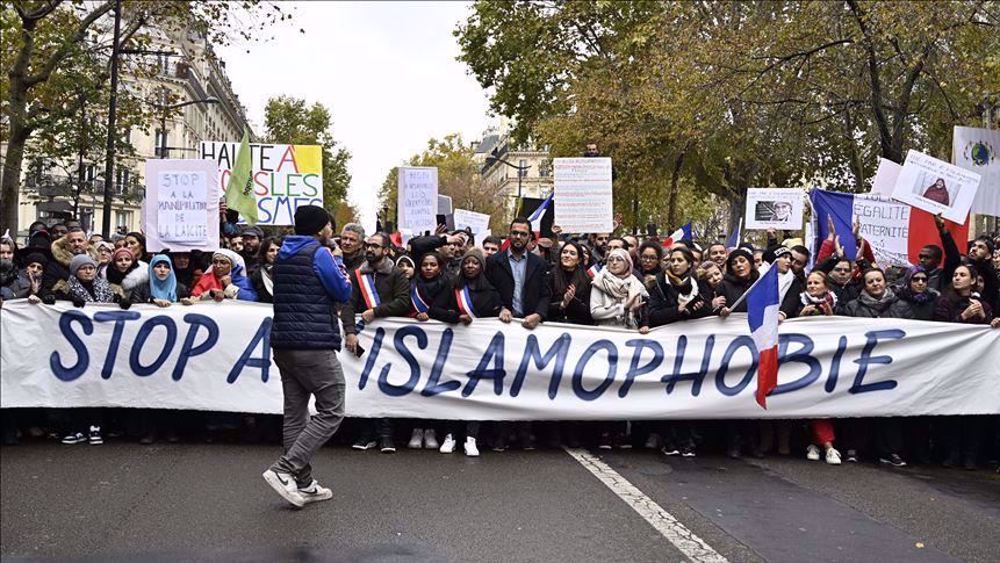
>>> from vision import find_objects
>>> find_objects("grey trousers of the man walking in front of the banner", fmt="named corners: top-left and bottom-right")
top-left (271, 350), bottom-right (344, 487)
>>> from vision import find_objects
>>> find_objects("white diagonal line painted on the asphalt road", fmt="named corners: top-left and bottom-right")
top-left (566, 448), bottom-right (727, 563)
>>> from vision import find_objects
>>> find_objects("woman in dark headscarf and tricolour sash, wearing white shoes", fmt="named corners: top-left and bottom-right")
top-left (439, 248), bottom-right (502, 457)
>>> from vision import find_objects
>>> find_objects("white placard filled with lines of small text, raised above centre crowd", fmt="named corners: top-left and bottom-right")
top-left (553, 157), bottom-right (615, 233)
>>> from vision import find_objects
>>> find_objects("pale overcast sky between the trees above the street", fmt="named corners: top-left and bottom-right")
top-left (219, 2), bottom-right (490, 229)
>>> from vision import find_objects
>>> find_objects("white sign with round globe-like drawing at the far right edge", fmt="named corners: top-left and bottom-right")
top-left (951, 127), bottom-right (1000, 217)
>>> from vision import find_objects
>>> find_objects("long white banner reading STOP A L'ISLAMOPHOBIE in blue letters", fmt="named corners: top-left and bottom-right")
top-left (0, 300), bottom-right (1000, 420)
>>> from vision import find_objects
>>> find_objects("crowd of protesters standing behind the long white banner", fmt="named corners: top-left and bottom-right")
top-left (0, 209), bottom-right (1000, 469)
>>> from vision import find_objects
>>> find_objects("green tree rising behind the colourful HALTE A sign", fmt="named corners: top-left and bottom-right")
top-left (264, 96), bottom-right (356, 218)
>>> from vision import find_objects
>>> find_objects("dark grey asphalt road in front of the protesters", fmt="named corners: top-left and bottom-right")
top-left (0, 443), bottom-right (1000, 563)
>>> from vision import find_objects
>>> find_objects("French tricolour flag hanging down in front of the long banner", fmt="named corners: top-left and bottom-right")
top-left (746, 266), bottom-right (781, 409)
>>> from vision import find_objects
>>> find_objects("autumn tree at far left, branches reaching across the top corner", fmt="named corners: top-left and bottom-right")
top-left (0, 0), bottom-right (289, 232)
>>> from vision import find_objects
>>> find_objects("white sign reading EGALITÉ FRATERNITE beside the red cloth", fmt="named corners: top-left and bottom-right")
top-left (853, 194), bottom-right (910, 267)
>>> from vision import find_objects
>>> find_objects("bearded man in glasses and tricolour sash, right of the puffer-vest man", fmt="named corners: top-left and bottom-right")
top-left (340, 229), bottom-right (410, 453)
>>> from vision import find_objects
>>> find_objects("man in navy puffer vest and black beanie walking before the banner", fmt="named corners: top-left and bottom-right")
top-left (264, 205), bottom-right (351, 507)
